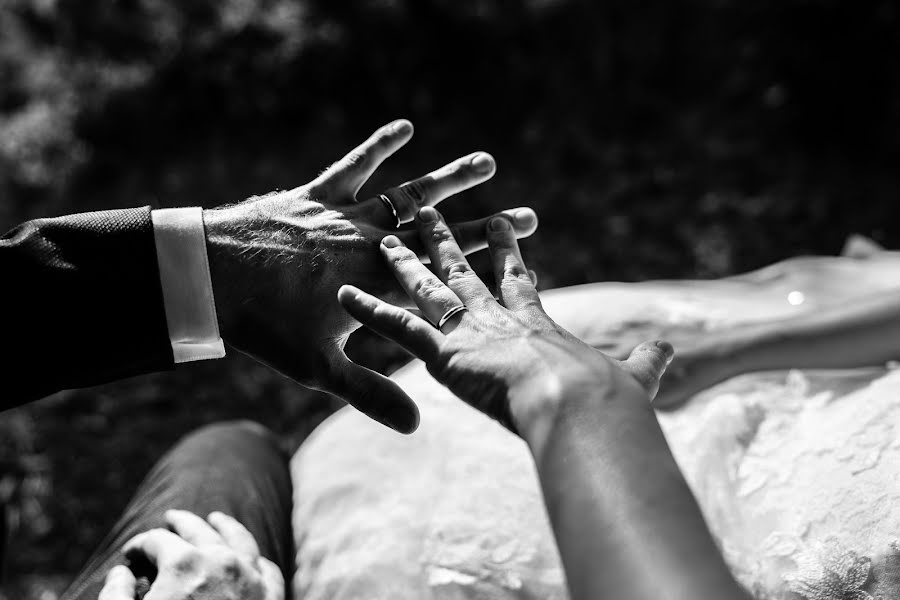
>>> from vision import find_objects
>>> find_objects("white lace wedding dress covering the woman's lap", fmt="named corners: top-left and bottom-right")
top-left (292, 256), bottom-right (900, 600)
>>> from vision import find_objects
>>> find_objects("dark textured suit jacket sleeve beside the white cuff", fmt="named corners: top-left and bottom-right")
top-left (0, 207), bottom-right (173, 410)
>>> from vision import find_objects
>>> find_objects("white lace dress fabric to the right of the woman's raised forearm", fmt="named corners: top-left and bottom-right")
top-left (660, 370), bottom-right (900, 600)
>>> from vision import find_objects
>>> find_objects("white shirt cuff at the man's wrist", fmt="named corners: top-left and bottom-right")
top-left (150, 207), bottom-right (225, 363)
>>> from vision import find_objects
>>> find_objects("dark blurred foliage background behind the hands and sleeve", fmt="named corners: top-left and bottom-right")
top-left (0, 0), bottom-right (900, 599)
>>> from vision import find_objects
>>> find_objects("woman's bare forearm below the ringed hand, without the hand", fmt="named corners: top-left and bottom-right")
top-left (523, 388), bottom-right (745, 600)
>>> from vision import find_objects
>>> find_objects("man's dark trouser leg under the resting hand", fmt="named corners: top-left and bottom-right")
top-left (61, 421), bottom-right (294, 600)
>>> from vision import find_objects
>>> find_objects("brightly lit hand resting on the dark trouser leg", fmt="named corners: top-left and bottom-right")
top-left (97, 510), bottom-right (284, 600)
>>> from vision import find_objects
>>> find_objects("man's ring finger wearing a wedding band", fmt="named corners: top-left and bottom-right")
top-left (365, 152), bottom-right (496, 229)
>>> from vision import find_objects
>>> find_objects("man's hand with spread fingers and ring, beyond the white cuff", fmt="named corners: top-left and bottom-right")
top-left (204, 120), bottom-right (537, 433)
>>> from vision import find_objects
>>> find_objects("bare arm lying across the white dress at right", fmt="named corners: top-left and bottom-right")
top-left (654, 290), bottom-right (900, 408)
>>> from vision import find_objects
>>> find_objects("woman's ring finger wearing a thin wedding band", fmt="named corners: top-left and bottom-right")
top-left (381, 235), bottom-right (463, 333)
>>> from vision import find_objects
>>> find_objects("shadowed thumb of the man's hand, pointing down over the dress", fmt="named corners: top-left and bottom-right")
top-left (320, 352), bottom-right (419, 433)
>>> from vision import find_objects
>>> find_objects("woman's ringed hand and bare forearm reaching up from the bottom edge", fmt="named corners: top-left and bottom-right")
top-left (339, 208), bottom-right (746, 600)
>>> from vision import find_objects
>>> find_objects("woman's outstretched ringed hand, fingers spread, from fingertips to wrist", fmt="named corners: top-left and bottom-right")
top-left (338, 207), bottom-right (673, 446)
